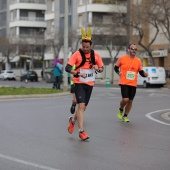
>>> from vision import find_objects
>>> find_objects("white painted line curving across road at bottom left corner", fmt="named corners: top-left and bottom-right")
top-left (0, 154), bottom-right (59, 170)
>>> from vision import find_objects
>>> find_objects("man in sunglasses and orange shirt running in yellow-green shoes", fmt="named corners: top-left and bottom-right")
top-left (114, 44), bottom-right (148, 122)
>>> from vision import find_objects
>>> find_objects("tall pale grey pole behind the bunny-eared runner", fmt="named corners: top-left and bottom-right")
top-left (63, 0), bottom-right (68, 91)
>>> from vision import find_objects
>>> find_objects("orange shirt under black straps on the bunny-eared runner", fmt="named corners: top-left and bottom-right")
top-left (68, 51), bottom-right (104, 86)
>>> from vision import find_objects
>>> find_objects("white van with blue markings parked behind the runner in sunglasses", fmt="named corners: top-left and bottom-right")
top-left (137, 66), bottom-right (166, 88)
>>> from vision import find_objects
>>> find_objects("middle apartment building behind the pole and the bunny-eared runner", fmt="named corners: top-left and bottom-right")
top-left (45, 0), bottom-right (127, 78)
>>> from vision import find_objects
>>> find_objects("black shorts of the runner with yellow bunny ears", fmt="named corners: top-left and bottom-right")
top-left (75, 83), bottom-right (93, 106)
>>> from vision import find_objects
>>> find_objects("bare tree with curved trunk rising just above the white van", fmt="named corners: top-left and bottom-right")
top-left (124, 1), bottom-right (159, 65)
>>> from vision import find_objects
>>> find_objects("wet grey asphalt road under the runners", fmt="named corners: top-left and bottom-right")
top-left (0, 83), bottom-right (170, 170)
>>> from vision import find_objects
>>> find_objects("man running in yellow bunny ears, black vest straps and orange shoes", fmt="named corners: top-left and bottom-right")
top-left (65, 28), bottom-right (104, 140)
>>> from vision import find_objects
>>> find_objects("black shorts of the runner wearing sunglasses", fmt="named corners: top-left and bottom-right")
top-left (120, 85), bottom-right (136, 100)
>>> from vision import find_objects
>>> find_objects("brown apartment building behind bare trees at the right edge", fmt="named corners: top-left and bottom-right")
top-left (130, 0), bottom-right (170, 73)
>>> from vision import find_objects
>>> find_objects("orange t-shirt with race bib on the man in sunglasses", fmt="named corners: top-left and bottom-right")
top-left (116, 55), bottom-right (142, 87)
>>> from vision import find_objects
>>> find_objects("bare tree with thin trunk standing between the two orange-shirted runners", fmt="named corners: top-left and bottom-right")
top-left (93, 12), bottom-right (127, 84)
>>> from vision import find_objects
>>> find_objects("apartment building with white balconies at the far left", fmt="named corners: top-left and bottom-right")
top-left (0, 0), bottom-right (46, 69)
